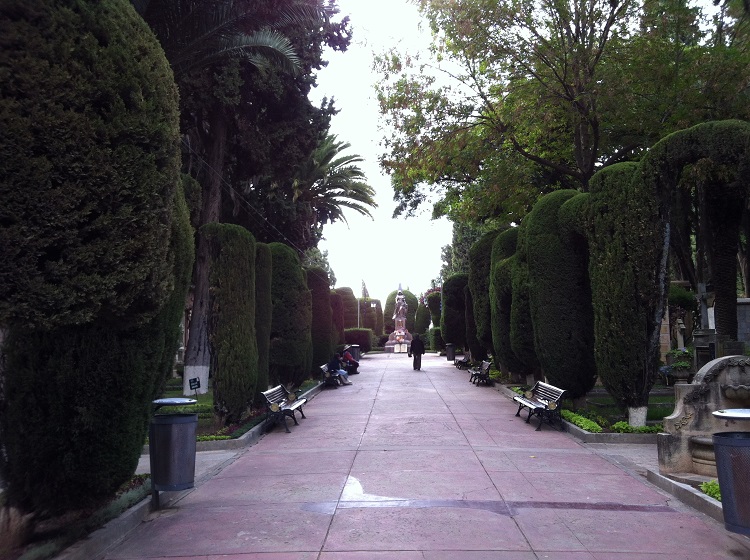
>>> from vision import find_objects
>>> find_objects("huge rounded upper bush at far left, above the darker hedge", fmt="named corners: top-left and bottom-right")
top-left (0, 0), bottom-right (180, 329)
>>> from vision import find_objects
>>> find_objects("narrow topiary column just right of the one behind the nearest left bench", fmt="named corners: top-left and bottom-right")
top-left (254, 243), bottom-right (273, 398)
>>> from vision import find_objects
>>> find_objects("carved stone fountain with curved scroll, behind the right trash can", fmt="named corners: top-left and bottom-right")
top-left (657, 356), bottom-right (750, 484)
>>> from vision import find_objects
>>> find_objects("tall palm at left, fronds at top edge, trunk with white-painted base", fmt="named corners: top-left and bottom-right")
top-left (131, 0), bottom-right (325, 394)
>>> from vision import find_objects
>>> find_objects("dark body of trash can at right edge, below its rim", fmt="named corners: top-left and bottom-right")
top-left (713, 432), bottom-right (750, 536)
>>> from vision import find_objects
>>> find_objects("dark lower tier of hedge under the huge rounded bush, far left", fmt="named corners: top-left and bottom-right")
top-left (0, 186), bottom-right (194, 514)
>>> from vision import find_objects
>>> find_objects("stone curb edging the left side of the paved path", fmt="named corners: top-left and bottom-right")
top-left (55, 382), bottom-right (323, 560)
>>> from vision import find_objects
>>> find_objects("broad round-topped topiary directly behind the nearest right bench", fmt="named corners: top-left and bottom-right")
top-left (525, 190), bottom-right (596, 399)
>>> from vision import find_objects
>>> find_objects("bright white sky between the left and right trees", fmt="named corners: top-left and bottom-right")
top-left (310, 0), bottom-right (452, 304)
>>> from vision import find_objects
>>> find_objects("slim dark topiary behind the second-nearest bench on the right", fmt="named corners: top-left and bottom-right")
top-left (469, 230), bottom-right (500, 353)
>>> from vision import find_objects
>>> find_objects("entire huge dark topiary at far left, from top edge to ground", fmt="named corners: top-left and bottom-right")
top-left (0, 0), bottom-right (184, 528)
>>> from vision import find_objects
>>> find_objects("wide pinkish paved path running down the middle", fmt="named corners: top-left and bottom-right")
top-left (106, 354), bottom-right (750, 560)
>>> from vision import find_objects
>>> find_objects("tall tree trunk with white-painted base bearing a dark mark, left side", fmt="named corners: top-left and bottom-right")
top-left (182, 109), bottom-right (227, 395)
